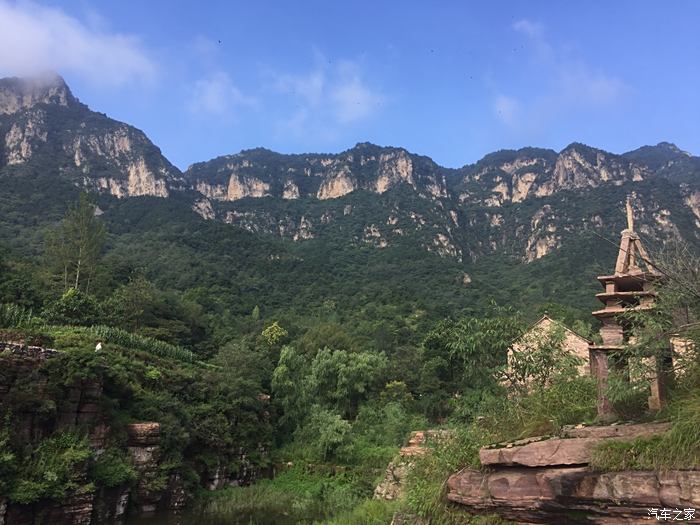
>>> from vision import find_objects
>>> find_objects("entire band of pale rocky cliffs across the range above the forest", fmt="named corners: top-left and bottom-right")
top-left (0, 77), bottom-right (700, 262)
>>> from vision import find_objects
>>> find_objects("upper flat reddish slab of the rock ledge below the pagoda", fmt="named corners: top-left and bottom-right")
top-left (479, 423), bottom-right (670, 467)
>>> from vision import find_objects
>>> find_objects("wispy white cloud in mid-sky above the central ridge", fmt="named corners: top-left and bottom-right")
top-left (274, 53), bottom-right (384, 138)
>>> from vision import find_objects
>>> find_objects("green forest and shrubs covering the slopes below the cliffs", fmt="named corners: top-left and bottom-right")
top-left (0, 177), bottom-right (700, 524)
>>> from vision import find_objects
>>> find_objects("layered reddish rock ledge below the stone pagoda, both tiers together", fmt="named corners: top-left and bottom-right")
top-left (447, 423), bottom-right (700, 524)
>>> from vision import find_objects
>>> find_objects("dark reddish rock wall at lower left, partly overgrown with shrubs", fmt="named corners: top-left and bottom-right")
top-left (0, 341), bottom-right (267, 525)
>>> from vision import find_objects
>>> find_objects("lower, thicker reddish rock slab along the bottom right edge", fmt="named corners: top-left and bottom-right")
top-left (447, 467), bottom-right (700, 524)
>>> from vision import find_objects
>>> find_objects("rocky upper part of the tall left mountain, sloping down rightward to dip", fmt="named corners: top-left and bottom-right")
top-left (0, 76), bottom-right (181, 197)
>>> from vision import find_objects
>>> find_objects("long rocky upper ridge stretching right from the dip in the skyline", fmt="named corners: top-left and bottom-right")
top-left (184, 143), bottom-right (700, 261)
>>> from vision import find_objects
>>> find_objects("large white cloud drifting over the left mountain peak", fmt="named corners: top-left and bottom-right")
top-left (0, 0), bottom-right (156, 86)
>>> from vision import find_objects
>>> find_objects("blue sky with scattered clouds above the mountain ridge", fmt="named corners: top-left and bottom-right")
top-left (0, 0), bottom-right (700, 169)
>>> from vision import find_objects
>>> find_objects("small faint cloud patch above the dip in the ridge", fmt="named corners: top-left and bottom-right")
top-left (189, 71), bottom-right (255, 117)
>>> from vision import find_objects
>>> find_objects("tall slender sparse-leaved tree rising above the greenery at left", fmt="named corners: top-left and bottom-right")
top-left (46, 193), bottom-right (107, 292)
